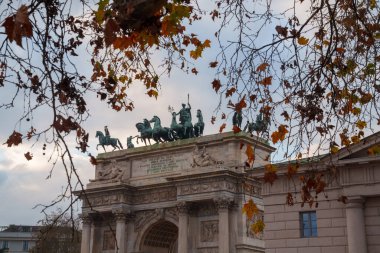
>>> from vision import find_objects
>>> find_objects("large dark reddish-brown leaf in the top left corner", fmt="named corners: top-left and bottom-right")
top-left (2, 5), bottom-right (33, 47)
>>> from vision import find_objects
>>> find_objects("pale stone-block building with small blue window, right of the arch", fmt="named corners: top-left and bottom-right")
top-left (250, 133), bottom-right (380, 253)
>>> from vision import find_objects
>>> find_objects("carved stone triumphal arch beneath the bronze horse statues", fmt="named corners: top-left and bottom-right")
top-left (78, 132), bottom-right (273, 253)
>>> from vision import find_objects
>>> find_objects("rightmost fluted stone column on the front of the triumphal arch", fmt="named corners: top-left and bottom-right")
top-left (215, 198), bottom-right (232, 253)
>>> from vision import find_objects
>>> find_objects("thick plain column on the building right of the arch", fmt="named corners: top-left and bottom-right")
top-left (346, 197), bottom-right (367, 253)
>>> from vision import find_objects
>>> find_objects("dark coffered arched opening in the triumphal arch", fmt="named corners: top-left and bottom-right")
top-left (141, 220), bottom-right (178, 253)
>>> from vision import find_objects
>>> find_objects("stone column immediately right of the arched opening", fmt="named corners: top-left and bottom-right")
top-left (177, 202), bottom-right (189, 253)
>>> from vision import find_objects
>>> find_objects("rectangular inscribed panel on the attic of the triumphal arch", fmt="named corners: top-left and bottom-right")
top-left (132, 153), bottom-right (191, 177)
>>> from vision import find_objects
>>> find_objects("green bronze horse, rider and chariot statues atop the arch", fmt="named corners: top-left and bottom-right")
top-left (95, 99), bottom-right (269, 151)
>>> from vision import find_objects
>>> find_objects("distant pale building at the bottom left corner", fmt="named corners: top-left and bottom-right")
top-left (0, 225), bottom-right (40, 253)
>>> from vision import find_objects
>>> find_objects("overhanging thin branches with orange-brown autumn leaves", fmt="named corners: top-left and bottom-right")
top-left (0, 0), bottom-right (380, 225)
